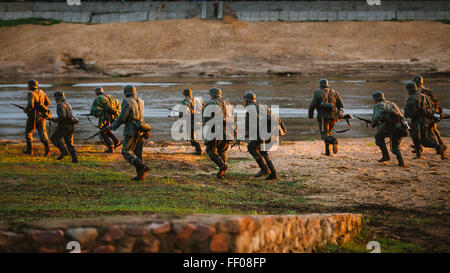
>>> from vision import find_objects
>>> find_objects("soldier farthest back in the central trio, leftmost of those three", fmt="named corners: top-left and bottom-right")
top-left (179, 88), bottom-right (204, 155)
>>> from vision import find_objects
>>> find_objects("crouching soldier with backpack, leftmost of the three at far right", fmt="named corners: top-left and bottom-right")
top-left (371, 91), bottom-right (406, 167)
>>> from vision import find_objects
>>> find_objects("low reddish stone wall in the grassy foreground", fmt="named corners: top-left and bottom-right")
top-left (0, 213), bottom-right (362, 253)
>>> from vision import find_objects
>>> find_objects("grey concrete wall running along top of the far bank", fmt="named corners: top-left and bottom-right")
top-left (0, 1), bottom-right (450, 24)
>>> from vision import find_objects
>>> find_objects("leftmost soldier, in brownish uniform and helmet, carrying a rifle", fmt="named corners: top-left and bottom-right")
top-left (23, 80), bottom-right (50, 157)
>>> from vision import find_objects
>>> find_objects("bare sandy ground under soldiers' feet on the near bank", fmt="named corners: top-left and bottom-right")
top-left (142, 138), bottom-right (450, 212)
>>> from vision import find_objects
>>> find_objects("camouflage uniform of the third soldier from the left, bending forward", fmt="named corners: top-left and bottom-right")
top-left (90, 92), bottom-right (121, 152)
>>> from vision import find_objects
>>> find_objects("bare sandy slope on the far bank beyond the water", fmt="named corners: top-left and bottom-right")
top-left (0, 17), bottom-right (450, 77)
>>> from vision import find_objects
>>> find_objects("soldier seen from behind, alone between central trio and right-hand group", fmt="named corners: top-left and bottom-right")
top-left (308, 79), bottom-right (344, 156)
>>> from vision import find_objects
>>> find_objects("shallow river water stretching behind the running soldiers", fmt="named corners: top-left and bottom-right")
top-left (0, 76), bottom-right (450, 141)
